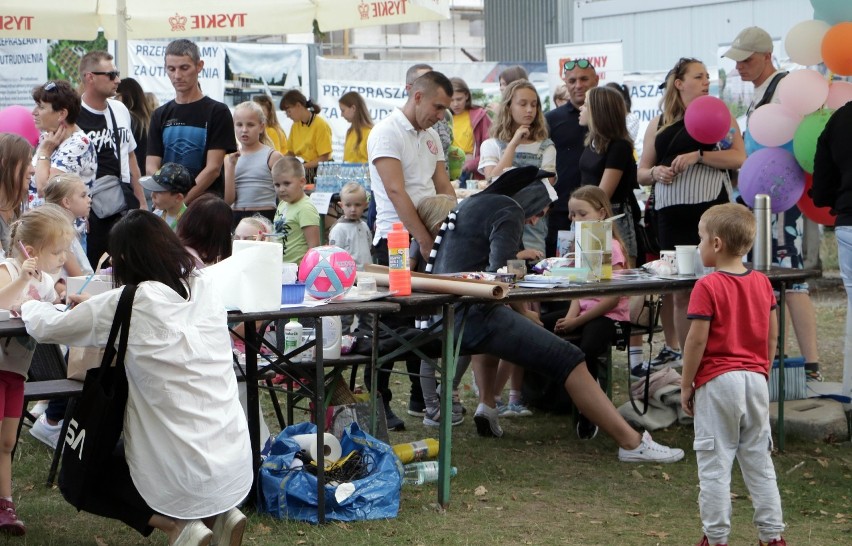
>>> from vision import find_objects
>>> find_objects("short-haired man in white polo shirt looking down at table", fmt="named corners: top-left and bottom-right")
top-left (367, 72), bottom-right (455, 264)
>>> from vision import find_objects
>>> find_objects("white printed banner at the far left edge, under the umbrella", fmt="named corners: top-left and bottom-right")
top-left (0, 38), bottom-right (47, 108)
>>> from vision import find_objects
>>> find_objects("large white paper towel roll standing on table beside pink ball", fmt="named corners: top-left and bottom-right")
top-left (204, 241), bottom-right (283, 313)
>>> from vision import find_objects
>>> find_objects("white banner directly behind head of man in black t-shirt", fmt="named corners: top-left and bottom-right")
top-left (126, 40), bottom-right (225, 104)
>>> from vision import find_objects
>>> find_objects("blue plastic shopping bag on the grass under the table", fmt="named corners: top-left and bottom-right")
top-left (258, 423), bottom-right (403, 523)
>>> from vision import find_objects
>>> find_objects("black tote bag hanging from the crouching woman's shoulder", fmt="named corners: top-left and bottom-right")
top-left (59, 285), bottom-right (136, 510)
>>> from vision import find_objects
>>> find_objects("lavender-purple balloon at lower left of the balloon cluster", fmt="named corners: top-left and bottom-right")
top-left (739, 148), bottom-right (805, 213)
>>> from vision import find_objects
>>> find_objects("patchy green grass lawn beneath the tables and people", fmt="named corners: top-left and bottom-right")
top-left (11, 282), bottom-right (852, 546)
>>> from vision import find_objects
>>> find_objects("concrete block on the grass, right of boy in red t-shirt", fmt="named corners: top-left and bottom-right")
top-left (769, 398), bottom-right (849, 442)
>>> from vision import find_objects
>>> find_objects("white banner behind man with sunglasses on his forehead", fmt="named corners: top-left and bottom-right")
top-left (544, 41), bottom-right (624, 95)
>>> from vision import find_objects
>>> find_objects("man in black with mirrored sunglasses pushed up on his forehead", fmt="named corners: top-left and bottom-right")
top-left (544, 59), bottom-right (598, 256)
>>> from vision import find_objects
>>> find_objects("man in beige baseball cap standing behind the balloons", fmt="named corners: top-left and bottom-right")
top-left (724, 27), bottom-right (822, 381)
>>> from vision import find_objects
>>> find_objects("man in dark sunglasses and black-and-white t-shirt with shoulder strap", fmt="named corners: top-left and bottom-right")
top-left (77, 51), bottom-right (147, 264)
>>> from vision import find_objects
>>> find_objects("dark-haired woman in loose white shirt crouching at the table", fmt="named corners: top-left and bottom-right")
top-left (22, 210), bottom-right (252, 545)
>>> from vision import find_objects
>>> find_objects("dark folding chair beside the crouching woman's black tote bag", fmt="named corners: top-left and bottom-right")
top-left (12, 343), bottom-right (83, 487)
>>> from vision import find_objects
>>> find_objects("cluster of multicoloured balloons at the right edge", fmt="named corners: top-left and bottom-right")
top-left (739, 0), bottom-right (852, 226)
